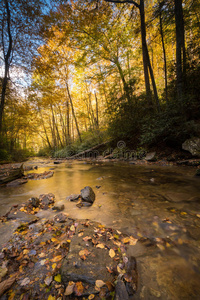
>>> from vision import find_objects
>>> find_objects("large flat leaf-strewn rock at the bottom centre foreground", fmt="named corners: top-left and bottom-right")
top-left (61, 222), bottom-right (117, 294)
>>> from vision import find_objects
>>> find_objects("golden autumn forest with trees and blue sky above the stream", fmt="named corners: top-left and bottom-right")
top-left (0, 0), bottom-right (200, 159)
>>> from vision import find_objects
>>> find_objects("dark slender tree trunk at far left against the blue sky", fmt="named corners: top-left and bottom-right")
top-left (0, 0), bottom-right (12, 134)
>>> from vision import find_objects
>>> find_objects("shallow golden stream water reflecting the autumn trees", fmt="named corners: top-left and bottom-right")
top-left (0, 160), bottom-right (200, 300)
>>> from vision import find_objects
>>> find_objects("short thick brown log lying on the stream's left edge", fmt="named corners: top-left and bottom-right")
top-left (0, 164), bottom-right (24, 184)
